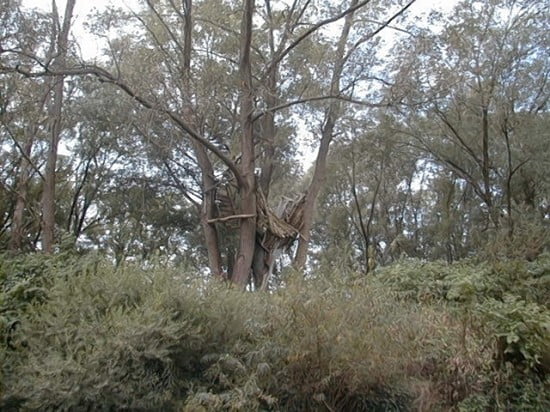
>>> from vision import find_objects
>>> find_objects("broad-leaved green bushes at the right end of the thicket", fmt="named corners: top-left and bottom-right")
top-left (375, 254), bottom-right (550, 410)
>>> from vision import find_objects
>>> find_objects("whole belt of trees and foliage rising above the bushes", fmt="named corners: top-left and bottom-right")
top-left (0, 0), bottom-right (550, 288)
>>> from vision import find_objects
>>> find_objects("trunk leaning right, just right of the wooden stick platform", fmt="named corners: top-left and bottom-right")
top-left (294, 0), bottom-right (358, 269)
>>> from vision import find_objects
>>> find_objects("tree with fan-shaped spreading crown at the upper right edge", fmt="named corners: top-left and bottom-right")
top-left (393, 1), bottom-right (550, 235)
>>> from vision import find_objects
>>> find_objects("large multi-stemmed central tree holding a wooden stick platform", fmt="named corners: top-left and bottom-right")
top-left (2, 0), bottom-right (418, 286)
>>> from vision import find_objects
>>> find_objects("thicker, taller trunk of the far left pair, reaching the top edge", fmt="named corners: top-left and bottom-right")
top-left (42, 0), bottom-right (76, 253)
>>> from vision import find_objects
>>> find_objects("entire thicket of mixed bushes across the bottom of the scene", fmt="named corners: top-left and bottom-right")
top-left (0, 253), bottom-right (550, 411)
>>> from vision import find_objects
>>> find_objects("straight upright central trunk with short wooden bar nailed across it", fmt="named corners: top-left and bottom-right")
top-left (231, 0), bottom-right (256, 288)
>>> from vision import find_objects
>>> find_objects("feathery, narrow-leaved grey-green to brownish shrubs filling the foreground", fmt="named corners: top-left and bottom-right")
top-left (0, 256), bottom-right (487, 411)
